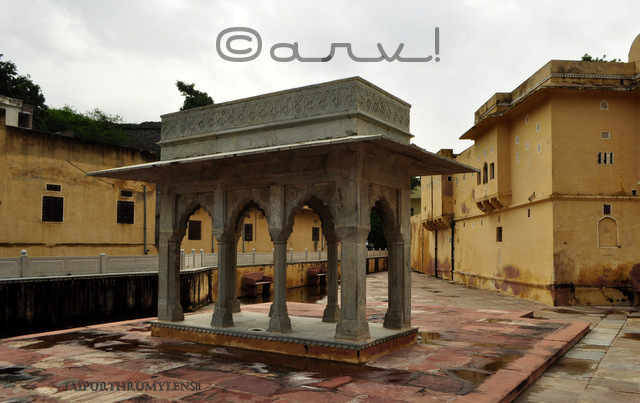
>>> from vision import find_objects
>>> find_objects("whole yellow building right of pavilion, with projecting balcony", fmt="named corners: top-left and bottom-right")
top-left (412, 35), bottom-right (640, 305)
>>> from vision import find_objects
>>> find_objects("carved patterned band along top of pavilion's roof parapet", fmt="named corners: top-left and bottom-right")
top-left (162, 80), bottom-right (409, 140)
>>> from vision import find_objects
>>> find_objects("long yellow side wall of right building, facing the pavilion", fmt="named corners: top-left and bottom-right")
top-left (414, 102), bottom-right (553, 303)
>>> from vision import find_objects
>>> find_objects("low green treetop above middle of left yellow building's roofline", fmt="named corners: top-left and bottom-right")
top-left (45, 105), bottom-right (129, 145)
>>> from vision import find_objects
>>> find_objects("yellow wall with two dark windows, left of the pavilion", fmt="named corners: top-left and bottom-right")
top-left (0, 113), bottom-right (157, 257)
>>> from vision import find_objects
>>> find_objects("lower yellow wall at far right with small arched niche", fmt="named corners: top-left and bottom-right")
top-left (554, 198), bottom-right (640, 305)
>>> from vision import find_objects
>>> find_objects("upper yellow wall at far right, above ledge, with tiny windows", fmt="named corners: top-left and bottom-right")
top-left (552, 91), bottom-right (640, 195)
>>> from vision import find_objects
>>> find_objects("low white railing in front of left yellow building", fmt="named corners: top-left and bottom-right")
top-left (0, 249), bottom-right (387, 279)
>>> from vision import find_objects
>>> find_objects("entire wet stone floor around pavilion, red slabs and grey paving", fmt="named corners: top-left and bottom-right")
top-left (0, 273), bottom-right (640, 403)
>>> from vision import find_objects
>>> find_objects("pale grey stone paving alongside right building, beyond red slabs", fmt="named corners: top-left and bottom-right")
top-left (360, 273), bottom-right (640, 403)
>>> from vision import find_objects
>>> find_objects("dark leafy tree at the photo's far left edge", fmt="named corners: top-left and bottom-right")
top-left (0, 53), bottom-right (47, 130)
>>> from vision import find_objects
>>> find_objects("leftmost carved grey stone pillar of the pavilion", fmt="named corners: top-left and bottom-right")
top-left (158, 193), bottom-right (184, 321)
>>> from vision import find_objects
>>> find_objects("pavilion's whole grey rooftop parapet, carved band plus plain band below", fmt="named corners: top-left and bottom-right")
top-left (158, 77), bottom-right (412, 160)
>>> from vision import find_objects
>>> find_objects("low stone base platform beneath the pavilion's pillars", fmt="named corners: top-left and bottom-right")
top-left (151, 311), bottom-right (418, 364)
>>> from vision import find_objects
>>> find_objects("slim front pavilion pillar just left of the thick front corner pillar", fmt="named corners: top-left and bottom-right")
top-left (269, 239), bottom-right (291, 333)
